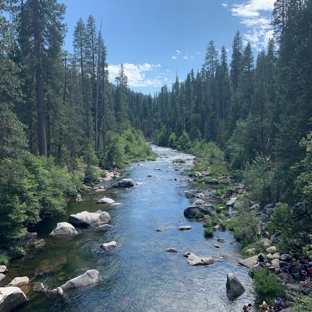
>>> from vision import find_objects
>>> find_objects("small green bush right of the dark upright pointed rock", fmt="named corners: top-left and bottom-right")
top-left (252, 269), bottom-right (286, 305)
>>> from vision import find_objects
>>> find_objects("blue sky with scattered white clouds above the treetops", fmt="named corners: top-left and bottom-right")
top-left (59, 0), bottom-right (274, 96)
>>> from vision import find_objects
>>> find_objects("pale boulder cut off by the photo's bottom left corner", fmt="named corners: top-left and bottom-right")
top-left (0, 287), bottom-right (27, 312)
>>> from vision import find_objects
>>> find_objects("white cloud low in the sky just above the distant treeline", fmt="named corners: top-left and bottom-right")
top-left (108, 63), bottom-right (162, 87)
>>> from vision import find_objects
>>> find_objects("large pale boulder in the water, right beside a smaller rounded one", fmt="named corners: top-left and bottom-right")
top-left (68, 210), bottom-right (111, 227)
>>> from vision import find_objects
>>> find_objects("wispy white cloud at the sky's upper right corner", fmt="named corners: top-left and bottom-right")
top-left (222, 0), bottom-right (275, 50)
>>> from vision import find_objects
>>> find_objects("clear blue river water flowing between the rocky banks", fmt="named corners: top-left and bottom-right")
top-left (7, 146), bottom-right (254, 312)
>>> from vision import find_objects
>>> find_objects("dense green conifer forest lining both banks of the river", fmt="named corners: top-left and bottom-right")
top-left (0, 0), bottom-right (312, 264)
